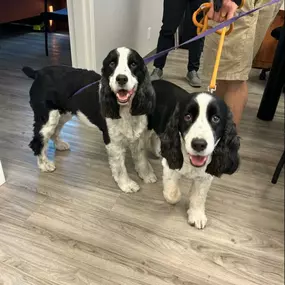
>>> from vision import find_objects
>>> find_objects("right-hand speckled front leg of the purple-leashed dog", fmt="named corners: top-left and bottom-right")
top-left (130, 135), bottom-right (157, 183)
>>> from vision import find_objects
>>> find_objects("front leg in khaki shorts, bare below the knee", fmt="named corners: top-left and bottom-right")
top-left (204, 1), bottom-right (255, 127)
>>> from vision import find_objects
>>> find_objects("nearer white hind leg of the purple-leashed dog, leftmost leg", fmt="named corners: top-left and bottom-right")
top-left (37, 110), bottom-right (60, 172)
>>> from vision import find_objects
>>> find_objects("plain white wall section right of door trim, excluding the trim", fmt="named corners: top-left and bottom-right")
top-left (94, 0), bottom-right (163, 68)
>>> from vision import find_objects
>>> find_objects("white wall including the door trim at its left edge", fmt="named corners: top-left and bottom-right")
top-left (67, 0), bottom-right (163, 72)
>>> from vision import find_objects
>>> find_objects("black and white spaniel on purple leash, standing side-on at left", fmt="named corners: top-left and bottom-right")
top-left (23, 47), bottom-right (157, 192)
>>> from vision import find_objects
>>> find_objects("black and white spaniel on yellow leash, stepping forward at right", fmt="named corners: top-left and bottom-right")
top-left (146, 80), bottom-right (240, 229)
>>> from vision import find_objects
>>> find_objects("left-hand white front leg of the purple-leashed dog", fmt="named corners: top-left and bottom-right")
top-left (106, 143), bottom-right (140, 193)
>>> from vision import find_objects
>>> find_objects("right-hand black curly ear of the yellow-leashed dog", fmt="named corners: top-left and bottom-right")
top-left (206, 109), bottom-right (240, 177)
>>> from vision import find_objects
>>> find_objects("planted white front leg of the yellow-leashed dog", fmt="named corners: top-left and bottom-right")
top-left (187, 175), bottom-right (213, 229)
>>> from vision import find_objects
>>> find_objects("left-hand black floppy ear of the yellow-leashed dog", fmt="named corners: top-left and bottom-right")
top-left (159, 105), bottom-right (183, 169)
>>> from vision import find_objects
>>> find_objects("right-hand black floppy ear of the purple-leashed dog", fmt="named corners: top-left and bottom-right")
top-left (131, 65), bottom-right (155, 116)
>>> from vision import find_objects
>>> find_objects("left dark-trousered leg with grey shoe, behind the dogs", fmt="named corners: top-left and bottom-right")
top-left (151, 0), bottom-right (187, 80)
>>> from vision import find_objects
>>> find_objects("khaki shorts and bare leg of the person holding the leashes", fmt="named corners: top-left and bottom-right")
top-left (203, 0), bottom-right (280, 126)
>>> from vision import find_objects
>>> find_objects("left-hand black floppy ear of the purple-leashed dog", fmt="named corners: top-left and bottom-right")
top-left (99, 77), bottom-right (121, 119)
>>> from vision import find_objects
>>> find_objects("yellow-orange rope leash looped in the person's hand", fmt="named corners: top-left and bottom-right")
top-left (192, 0), bottom-right (245, 93)
